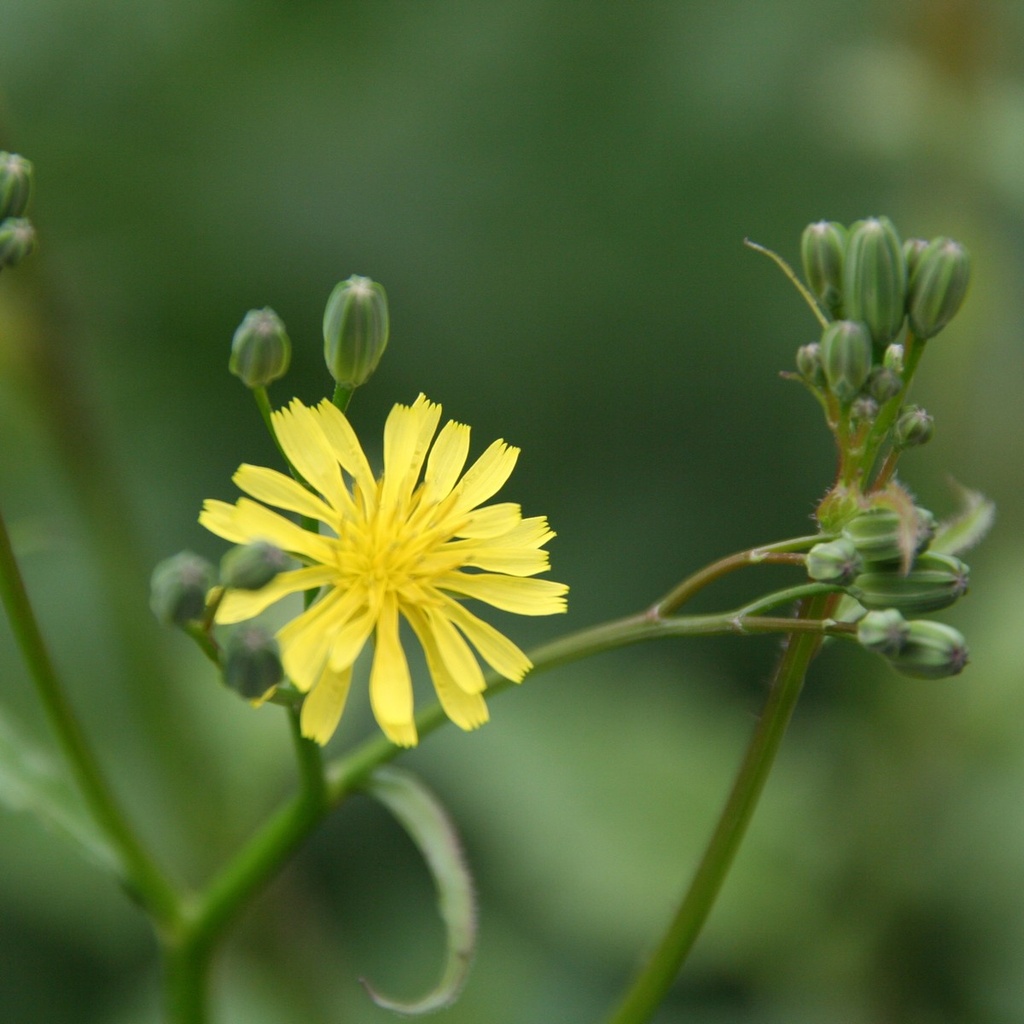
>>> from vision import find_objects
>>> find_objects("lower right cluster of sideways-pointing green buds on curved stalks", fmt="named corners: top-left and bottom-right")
top-left (807, 508), bottom-right (970, 679)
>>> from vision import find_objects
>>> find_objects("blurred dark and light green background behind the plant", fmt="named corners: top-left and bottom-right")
top-left (0, 0), bottom-right (1024, 1024)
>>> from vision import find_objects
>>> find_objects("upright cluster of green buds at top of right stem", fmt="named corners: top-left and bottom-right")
top-left (797, 217), bottom-right (971, 432)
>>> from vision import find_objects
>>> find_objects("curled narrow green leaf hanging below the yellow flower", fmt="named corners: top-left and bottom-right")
top-left (362, 767), bottom-right (476, 1016)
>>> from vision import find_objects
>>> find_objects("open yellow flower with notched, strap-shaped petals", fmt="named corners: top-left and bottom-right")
top-left (200, 394), bottom-right (568, 746)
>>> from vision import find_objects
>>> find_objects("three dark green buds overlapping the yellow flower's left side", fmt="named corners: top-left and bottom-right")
top-left (150, 541), bottom-right (291, 700)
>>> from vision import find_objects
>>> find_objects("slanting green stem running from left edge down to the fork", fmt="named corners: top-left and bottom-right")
top-left (0, 505), bottom-right (179, 932)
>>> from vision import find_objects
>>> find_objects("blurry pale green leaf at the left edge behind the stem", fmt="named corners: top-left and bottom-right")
top-left (0, 711), bottom-right (118, 871)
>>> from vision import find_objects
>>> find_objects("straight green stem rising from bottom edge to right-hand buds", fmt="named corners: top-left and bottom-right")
top-left (607, 594), bottom-right (835, 1024)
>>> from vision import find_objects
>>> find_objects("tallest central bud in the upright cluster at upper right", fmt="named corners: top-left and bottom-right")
top-left (843, 217), bottom-right (906, 349)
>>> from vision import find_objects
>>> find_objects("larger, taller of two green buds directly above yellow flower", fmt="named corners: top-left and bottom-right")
top-left (324, 274), bottom-right (389, 388)
